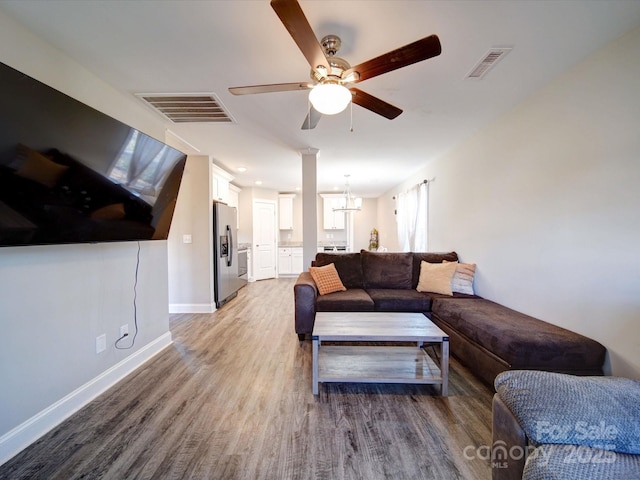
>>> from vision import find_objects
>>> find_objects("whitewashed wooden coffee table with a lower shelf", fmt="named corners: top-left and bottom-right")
top-left (311, 312), bottom-right (449, 397)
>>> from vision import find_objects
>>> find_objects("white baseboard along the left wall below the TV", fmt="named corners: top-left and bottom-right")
top-left (0, 332), bottom-right (173, 465)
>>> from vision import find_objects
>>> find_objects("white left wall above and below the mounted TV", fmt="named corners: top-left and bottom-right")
top-left (0, 12), bottom-right (171, 463)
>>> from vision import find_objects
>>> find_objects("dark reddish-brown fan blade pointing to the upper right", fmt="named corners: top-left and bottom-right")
top-left (342, 35), bottom-right (442, 82)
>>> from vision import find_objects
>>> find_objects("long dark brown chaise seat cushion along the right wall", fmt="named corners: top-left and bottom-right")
top-left (431, 297), bottom-right (606, 373)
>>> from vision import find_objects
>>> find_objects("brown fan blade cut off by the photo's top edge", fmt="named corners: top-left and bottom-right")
top-left (271, 0), bottom-right (330, 76)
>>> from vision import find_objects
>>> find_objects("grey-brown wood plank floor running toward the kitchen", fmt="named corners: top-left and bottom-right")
top-left (0, 279), bottom-right (493, 480)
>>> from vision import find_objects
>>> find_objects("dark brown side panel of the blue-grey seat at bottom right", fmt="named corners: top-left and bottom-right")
top-left (491, 394), bottom-right (528, 480)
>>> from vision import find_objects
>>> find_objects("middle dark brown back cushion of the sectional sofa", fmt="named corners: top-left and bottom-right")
top-left (360, 250), bottom-right (413, 289)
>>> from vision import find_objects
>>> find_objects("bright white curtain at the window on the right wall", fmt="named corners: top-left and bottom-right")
top-left (396, 182), bottom-right (429, 252)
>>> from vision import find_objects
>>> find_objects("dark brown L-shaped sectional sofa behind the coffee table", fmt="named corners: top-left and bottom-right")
top-left (294, 250), bottom-right (606, 384)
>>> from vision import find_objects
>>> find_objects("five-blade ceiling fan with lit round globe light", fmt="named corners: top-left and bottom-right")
top-left (229, 0), bottom-right (442, 130)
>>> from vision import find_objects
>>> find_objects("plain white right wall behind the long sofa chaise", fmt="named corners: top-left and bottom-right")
top-left (378, 29), bottom-right (640, 378)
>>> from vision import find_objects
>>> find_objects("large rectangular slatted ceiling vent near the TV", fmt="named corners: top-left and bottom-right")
top-left (136, 93), bottom-right (235, 123)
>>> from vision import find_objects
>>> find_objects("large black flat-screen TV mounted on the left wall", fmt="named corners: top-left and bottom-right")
top-left (0, 63), bottom-right (186, 247)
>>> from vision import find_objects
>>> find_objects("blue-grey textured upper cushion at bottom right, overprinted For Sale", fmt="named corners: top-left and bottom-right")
top-left (495, 370), bottom-right (640, 454)
